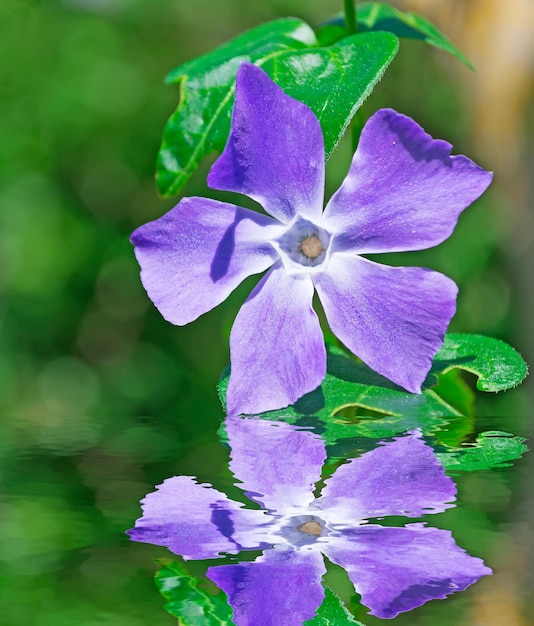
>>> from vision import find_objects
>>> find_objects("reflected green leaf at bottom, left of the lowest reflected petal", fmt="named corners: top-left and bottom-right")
top-left (156, 561), bottom-right (233, 626)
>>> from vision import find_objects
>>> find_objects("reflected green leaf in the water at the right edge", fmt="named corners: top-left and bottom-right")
top-left (437, 431), bottom-right (528, 472)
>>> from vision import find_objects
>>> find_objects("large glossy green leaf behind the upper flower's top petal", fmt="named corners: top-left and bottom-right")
top-left (156, 18), bottom-right (398, 196)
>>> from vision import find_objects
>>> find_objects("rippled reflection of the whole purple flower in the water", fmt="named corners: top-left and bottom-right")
top-left (128, 418), bottom-right (491, 626)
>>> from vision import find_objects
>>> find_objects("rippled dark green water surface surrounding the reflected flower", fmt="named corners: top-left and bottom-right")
top-left (0, 416), bottom-right (534, 626)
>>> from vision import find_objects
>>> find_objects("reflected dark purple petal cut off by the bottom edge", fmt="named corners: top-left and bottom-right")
top-left (207, 550), bottom-right (326, 626)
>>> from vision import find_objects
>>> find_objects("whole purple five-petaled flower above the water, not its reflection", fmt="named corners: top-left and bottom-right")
top-left (132, 63), bottom-right (491, 415)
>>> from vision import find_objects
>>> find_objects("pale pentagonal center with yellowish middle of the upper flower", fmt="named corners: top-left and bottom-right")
top-left (278, 218), bottom-right (330, 267)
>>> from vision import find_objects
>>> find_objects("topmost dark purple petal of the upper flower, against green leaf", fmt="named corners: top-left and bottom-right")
top-left (208, 63), bottom-right (324, 223)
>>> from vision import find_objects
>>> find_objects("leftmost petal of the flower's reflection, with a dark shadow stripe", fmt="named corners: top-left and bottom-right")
top-left (128, 476), bottom-right (270, 559)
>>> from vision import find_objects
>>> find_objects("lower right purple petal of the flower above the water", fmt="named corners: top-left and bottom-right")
top-left (315, 252), bottom-right (458, 393)
